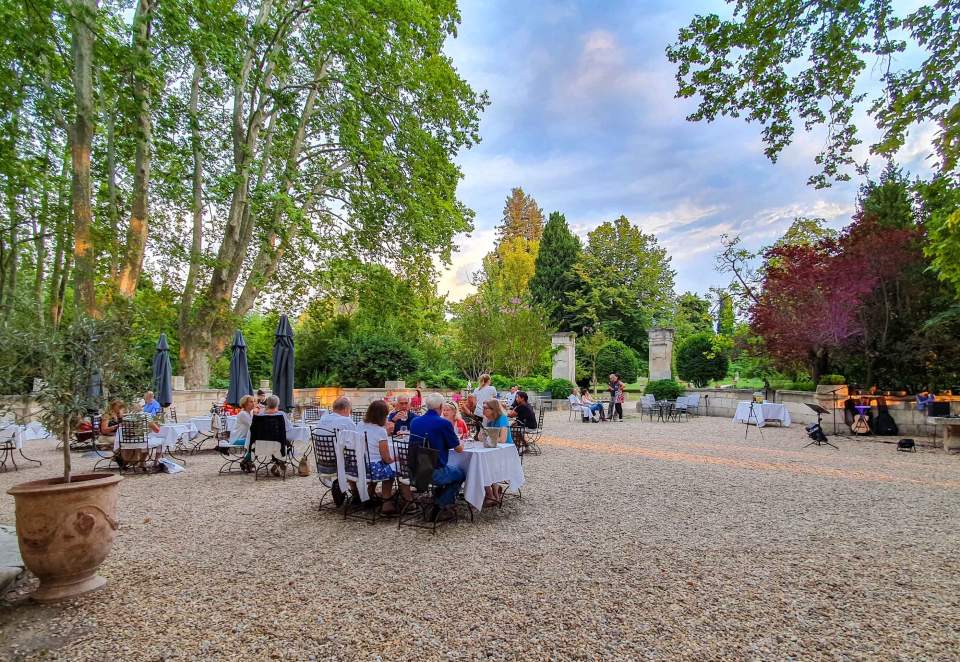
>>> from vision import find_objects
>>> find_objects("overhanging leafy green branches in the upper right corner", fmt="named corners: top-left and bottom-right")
top-left (667, 0), bottom-right (960, 186)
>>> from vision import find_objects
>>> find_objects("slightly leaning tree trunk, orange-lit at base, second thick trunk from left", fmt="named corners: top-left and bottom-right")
top-left (120, 0), bottom-right (156, 298)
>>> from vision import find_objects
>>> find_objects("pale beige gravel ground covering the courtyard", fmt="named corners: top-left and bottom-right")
top-left (0, 412), bottom-right (960, 660)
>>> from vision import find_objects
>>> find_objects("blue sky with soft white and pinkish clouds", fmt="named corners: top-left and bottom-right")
top-left (438, 0), bottom-right (932, 300)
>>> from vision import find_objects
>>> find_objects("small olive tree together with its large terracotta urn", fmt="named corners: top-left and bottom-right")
top-left (7, 319), bottom-right (141, 602)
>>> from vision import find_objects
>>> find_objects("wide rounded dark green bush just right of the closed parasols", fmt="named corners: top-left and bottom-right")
top-left (329, 333), bottom-right (420, 388)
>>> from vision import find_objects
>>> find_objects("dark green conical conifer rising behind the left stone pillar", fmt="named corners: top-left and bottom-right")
top-left (530, 211), bottom-right (580, 328)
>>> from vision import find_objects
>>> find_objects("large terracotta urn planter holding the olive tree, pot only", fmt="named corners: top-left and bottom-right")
top-left (7, 473), bottom-right (121, 602)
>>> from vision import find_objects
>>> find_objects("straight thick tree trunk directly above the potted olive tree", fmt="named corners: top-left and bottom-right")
top-left (70, 0), bottom-right (97, 316)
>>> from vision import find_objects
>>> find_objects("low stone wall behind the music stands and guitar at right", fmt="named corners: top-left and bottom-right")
top-left (686, 388), bottom-right (960, 444)
